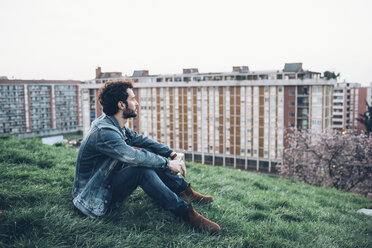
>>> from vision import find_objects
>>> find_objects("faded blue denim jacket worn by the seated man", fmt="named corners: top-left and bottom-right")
top-left (72, 115), bottom-right (172, 218)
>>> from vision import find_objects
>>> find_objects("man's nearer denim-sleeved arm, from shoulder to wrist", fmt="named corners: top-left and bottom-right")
top-left (96, 128), bottom-right (169, 168)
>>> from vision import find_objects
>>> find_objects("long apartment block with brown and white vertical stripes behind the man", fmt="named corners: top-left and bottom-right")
top-left (82, 63), bottom-right (334, 171)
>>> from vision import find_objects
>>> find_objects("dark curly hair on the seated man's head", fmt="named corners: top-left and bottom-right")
top-left (98, 79), bottom-right (133, 115)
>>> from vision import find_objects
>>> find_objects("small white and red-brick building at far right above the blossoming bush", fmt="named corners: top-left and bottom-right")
top-left (333, 82), bottom-right (369, 132)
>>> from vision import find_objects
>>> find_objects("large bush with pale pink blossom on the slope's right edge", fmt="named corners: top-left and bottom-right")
top-left (280, 130), bottom-right (372, 195)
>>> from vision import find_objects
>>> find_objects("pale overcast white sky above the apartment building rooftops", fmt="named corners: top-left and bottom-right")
top-left (0, 0), bottom-right (372, 85)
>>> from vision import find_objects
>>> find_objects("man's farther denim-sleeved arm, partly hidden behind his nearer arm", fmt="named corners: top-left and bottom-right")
top-left (125, 128), bottom-right (173, 158)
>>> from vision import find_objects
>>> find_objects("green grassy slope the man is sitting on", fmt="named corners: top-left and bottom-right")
top-left (0, 136), bottom-right (372, 248)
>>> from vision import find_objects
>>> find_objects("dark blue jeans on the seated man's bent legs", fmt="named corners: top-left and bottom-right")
top-left (111, 165), bottom-right (188, 218)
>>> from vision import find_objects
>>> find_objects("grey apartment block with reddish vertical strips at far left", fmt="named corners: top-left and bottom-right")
top-left (0, 79), bottom-right (82, 137)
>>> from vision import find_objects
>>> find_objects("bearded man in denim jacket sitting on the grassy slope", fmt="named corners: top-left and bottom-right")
top-left (72, 80), bottom-right (220, 233)
